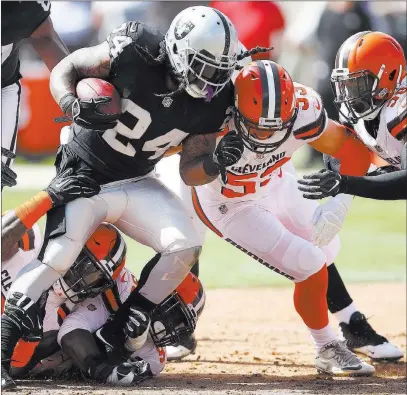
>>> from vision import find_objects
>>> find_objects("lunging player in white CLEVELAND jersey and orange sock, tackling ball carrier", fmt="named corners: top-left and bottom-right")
top-left (192, 61), bottom-right (388, 374)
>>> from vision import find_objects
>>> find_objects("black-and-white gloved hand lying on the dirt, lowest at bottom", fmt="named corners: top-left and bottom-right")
top-left (106, 358), bottom-right (152, 386)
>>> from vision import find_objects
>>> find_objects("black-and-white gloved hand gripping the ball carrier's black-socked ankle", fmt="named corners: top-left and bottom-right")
top-left (124, 307), bottom-right (151, 351)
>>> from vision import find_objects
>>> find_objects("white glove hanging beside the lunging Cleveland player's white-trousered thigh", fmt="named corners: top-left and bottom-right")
top-left (312, 194), bottom-right (352, 247)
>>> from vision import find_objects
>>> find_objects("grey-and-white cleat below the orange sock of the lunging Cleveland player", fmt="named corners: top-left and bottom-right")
top-left (315, 340), bottom-right (375, 376)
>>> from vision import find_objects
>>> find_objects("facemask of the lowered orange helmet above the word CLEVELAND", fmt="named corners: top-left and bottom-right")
top-left (235, 108), bottom-right (298, 154)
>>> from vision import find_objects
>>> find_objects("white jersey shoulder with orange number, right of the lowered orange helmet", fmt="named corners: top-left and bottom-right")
top-left (293, 82), bottom-right (327, 142)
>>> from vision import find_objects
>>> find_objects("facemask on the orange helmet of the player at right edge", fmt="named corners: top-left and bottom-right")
top-left (331, 69), bottom-right (389, 123)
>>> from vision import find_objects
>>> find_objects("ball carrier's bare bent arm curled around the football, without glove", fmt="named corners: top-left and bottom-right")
top-left (50, 41), bottom-right (110, 118)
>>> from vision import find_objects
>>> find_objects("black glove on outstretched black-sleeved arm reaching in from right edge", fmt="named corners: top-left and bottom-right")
top-left (298, 169), bottom-right (346, 200)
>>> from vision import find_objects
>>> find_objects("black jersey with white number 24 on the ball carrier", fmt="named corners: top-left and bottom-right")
top-left (69, 22), bottom-right (233, 186)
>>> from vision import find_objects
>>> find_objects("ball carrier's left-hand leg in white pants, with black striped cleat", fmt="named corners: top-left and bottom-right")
top-left (1, 191), bottom-right (126, 378)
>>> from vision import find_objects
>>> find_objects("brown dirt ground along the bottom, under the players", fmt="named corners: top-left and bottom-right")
top-left (13, 284), bottom-right (406, 395)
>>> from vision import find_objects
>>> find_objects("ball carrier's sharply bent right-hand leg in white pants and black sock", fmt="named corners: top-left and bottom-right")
top-left (101, 178), bottom-right (201, 348)
